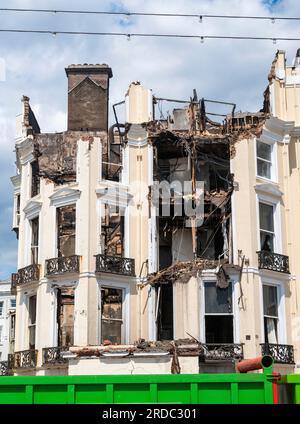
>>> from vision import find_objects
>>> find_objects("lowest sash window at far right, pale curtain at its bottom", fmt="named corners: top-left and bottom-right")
top-left (263, 285), bottom-right (279, 344)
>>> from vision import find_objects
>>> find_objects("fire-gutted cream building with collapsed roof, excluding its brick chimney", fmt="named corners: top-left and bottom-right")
top-left (10, 51), bottom-right (300, 375)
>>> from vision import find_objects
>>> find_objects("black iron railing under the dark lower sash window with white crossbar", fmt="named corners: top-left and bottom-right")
top-left (200, 343), bottom-right (244, 361)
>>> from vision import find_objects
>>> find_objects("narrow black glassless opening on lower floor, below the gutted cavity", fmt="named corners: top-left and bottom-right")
top-left (156, 283), bottom-right (174, 340)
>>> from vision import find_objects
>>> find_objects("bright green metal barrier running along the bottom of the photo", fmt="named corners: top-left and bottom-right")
top-left (0, 367), bottom-right (273, 404)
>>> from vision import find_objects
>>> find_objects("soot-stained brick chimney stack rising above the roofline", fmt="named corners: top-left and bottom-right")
top-left (65, 64), bottom-right (112, 131)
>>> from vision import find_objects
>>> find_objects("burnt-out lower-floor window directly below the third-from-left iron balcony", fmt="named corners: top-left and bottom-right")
top-left (101, 287), bottom-right (123, 344)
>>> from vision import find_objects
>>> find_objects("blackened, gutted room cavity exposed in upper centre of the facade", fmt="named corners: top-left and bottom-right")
top-left (154, 131), bottom-right (233, 270)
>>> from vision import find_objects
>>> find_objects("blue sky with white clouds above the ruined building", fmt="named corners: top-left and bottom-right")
top-left (0, 0), bottom-right (300, 279)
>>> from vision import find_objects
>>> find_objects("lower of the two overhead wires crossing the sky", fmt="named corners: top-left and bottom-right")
top-left (0, 28), bottom-right (300, 43)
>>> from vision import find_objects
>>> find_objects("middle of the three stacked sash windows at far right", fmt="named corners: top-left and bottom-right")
top-left (259, 202), bottom-right (275, 252)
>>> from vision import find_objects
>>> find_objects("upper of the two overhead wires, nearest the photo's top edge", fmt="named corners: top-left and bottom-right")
top-left (0, 7), bottom-right (300, 23)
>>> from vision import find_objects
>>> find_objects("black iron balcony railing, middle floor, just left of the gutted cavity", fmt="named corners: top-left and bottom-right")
top-left (96, 255), bottom-right (135, 276)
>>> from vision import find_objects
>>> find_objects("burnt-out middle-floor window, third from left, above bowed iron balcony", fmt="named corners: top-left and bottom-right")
top-left (101, 204), bottom-right (124, 256)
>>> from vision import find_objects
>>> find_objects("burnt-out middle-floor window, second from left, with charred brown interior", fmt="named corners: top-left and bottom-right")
top-left (57, 205), bottom-right (76, 257)
